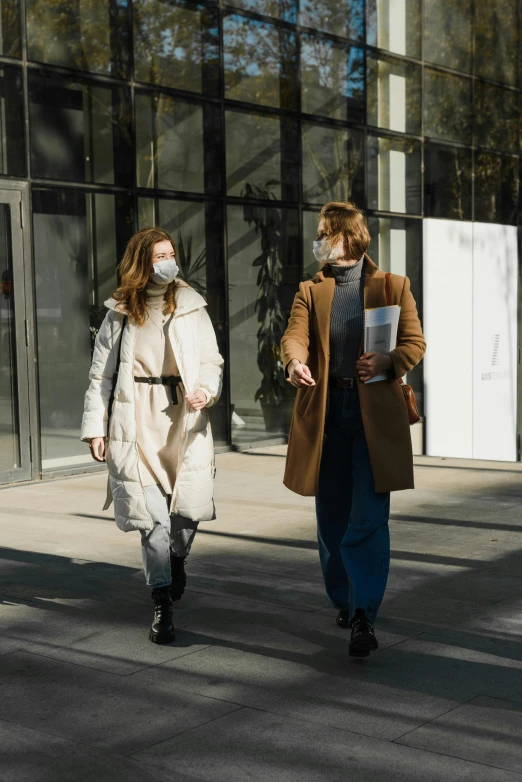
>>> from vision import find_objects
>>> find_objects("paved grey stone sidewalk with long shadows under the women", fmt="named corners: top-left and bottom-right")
top-left (0, 446), bottom-right (522, 782)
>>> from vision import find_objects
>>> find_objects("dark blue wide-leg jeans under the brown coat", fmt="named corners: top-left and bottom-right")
top-left (315, 389), bottom-right (390, 623)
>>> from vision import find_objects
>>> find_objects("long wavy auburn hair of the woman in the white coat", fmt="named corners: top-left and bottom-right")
top-left (112, 228), bottom-right (178, 326)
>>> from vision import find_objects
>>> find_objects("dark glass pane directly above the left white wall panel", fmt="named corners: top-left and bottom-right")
top-left (424, 144), bottom-right (472, 220)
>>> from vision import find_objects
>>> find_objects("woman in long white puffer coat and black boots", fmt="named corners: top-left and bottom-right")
top-left (81, 228), bottom-right (223, 643)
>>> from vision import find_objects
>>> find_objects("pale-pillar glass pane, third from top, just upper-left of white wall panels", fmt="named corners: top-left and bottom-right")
top-left (367, 136), bottom-right (421, 214)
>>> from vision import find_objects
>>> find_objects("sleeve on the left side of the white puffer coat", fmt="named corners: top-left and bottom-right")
top-left (81, 312), bottom-right (117, 448)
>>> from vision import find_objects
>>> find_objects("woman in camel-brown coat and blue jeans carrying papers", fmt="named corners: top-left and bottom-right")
top-left (281, 202), bottom-right (426, 657)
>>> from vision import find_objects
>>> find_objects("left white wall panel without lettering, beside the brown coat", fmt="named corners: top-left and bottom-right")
top-left (423, 219), bottom-right (473, 458)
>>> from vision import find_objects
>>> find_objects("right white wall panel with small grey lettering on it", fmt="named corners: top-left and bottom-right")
top-left (473, 223), bottom-right (518, 461)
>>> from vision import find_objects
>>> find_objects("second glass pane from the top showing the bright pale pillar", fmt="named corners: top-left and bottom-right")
top-left (367, 55), bottom-right (421, 135)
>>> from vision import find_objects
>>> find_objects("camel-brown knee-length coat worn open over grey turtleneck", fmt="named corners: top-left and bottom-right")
top-left (281, 255), bottom-right (426, 496)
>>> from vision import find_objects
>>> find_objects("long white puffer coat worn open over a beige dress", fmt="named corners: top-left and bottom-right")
top-left (81, 283), bottom-right (224, 532)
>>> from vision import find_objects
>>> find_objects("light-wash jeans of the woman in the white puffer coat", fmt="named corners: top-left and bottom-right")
top-left (141, 484), bottom-right (198, 588)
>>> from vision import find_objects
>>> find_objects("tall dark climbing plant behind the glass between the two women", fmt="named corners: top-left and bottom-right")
top-left (241, 180), bottom-right (286, 405)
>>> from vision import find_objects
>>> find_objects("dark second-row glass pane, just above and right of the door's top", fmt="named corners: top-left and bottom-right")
top-left (29, 74), bottom-right (132, 190)
